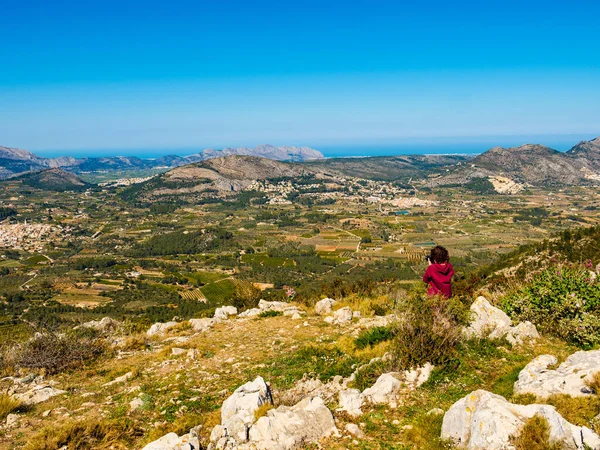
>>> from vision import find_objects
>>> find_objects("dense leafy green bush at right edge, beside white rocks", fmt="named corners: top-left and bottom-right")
top-left (503, 266), bottom-right (600, 348)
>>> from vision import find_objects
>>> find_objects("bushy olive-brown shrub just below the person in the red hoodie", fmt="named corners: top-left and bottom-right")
top-left (392, 295), bottom-right (469, 370)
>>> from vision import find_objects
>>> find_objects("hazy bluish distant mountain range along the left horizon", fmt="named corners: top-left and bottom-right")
top-left (0, 145), bottom-right (323, 179)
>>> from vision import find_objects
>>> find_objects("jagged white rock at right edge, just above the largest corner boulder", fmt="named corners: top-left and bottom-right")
top-left (514, 350), bottom-right (600, 399)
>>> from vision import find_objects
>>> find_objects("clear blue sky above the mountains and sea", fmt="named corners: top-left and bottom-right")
top-left (0, 0), bottom-right (600, 155)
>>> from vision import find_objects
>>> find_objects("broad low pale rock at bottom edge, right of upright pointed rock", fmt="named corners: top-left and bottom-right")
top-left (248, 397), bottom-right (338, 450)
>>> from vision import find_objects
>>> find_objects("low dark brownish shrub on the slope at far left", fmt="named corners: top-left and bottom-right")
top-left (15, 331), bottom-right (104, 373)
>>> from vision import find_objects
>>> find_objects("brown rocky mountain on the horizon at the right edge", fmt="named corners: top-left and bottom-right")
top-left (428, 138), bottom-right (600, 186)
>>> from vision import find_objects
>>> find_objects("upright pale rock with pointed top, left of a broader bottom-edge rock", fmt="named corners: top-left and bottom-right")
top-left (221, 377), bottom-right (273, 443)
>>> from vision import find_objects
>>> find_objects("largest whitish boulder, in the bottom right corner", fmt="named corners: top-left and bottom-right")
top-left (441, 390), bottom-right (600, 450)
